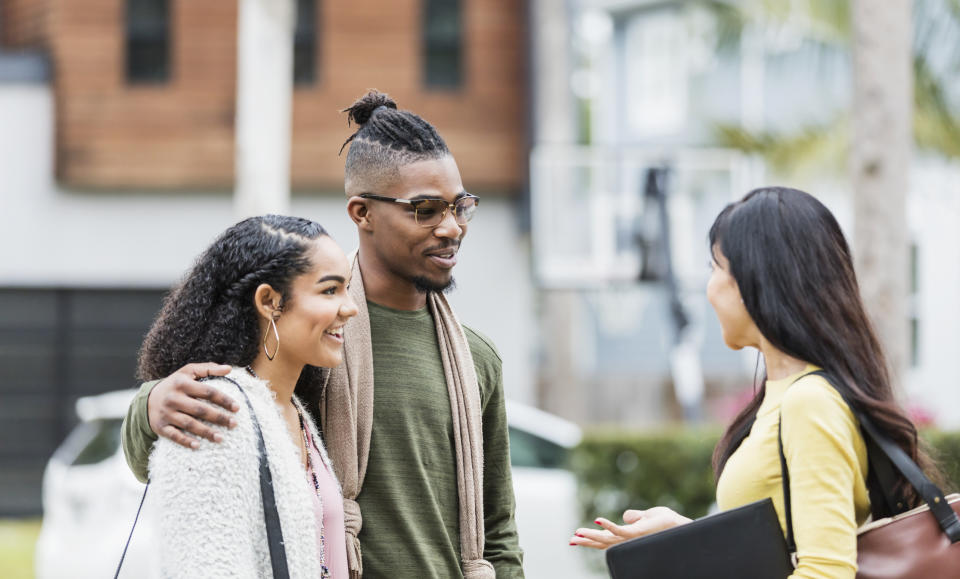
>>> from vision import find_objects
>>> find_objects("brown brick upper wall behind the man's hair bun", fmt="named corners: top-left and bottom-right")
top-left (45, 0), bottom-right (527, 191)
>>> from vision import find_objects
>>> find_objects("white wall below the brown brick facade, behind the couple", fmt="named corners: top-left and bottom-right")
top-left (0, 85), bottom-right (535, 402)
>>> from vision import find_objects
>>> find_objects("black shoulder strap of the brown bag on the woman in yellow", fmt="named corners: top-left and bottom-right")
top-left (777, 370), bottom-right (960, 549)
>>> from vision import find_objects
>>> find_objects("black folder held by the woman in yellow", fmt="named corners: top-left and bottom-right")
top-left (607, 498), bottom-right (793, 579)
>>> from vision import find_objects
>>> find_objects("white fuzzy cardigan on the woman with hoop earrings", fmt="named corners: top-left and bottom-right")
top-left (149, 368), bottom-right (333, 579)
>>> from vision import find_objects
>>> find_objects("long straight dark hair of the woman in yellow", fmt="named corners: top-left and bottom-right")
top-left (709, 187), bottom-right (936, 504)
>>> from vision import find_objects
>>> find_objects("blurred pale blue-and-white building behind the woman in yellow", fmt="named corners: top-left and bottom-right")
top-left (531, 0), bottom-right (960, 428)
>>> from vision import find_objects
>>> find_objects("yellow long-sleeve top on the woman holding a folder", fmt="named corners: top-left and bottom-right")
top-left (717, 366), bottom-right (870, 579)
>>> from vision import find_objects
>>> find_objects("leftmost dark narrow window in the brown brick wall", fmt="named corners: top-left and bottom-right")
top-left (126, 0), bottom-right (170, 84)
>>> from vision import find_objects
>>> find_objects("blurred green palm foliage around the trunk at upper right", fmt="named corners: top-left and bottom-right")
top-left (701, 0), bottom-right (960, 170)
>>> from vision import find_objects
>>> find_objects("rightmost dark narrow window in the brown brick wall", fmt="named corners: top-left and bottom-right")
top-left (423, 0), bottom-right (463, 88)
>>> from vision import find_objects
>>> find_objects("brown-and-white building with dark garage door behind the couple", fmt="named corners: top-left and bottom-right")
top-left (0, 0), bottom-right (535, 515)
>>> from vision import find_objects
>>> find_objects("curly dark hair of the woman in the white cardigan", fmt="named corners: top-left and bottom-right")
top-left (137, 215), bottom-right (327, 410)
